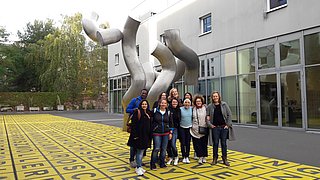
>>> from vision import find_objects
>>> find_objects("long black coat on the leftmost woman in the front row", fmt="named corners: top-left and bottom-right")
top-left (127, 109), bottom-right (152, 149)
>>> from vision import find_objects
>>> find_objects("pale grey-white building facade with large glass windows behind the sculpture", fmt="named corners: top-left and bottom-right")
top-left (108, 0), bottom-right (320, 131)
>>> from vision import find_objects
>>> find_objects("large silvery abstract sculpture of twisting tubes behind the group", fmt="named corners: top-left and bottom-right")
top-left (82, 15), bottom-right (199, 130)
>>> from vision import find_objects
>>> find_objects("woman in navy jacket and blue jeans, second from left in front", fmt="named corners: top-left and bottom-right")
top-left (150, 99), bottom-right (173, 170)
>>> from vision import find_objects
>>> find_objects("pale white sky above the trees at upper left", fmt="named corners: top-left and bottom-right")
top-left (0, 0), bottom-right (145, 38)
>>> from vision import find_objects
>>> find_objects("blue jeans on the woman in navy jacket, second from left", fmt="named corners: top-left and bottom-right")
top-left (151, 135), bottom-right (169, 166)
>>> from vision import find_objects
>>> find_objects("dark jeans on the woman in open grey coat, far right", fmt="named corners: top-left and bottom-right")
top-left (212, 127), bottom-right (229, 158)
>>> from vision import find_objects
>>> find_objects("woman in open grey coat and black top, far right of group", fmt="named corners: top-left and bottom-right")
top-left (207, 91), bottom-right (232, 166)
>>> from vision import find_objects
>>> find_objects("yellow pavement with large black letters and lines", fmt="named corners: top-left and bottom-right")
top-left (0, 114), bottom-right (320, 180)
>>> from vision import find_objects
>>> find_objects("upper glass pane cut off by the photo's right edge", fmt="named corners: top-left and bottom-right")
top-left (304, 33), bottom-right (320, 65)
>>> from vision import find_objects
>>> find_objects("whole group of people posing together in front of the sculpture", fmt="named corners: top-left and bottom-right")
top-left (126, 88), bottom-right (232, 175)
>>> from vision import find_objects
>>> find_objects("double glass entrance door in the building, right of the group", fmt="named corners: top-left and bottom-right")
top-left (259, 71), bottom-right (303, 128)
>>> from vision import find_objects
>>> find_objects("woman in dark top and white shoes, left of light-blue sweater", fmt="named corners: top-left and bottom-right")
top-left (167, 98), bottom-right (181, 166)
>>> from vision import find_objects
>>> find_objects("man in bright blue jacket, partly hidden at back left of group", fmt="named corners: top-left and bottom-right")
top-left (126, 89), bottom-right (148, 168)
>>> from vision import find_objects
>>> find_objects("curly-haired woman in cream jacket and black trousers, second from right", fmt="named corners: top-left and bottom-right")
top-left (190, 95), bottom-right (208, 164)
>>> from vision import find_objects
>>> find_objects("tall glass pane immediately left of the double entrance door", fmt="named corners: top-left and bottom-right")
top-left (238, 74), bottom-right (257, 124)
